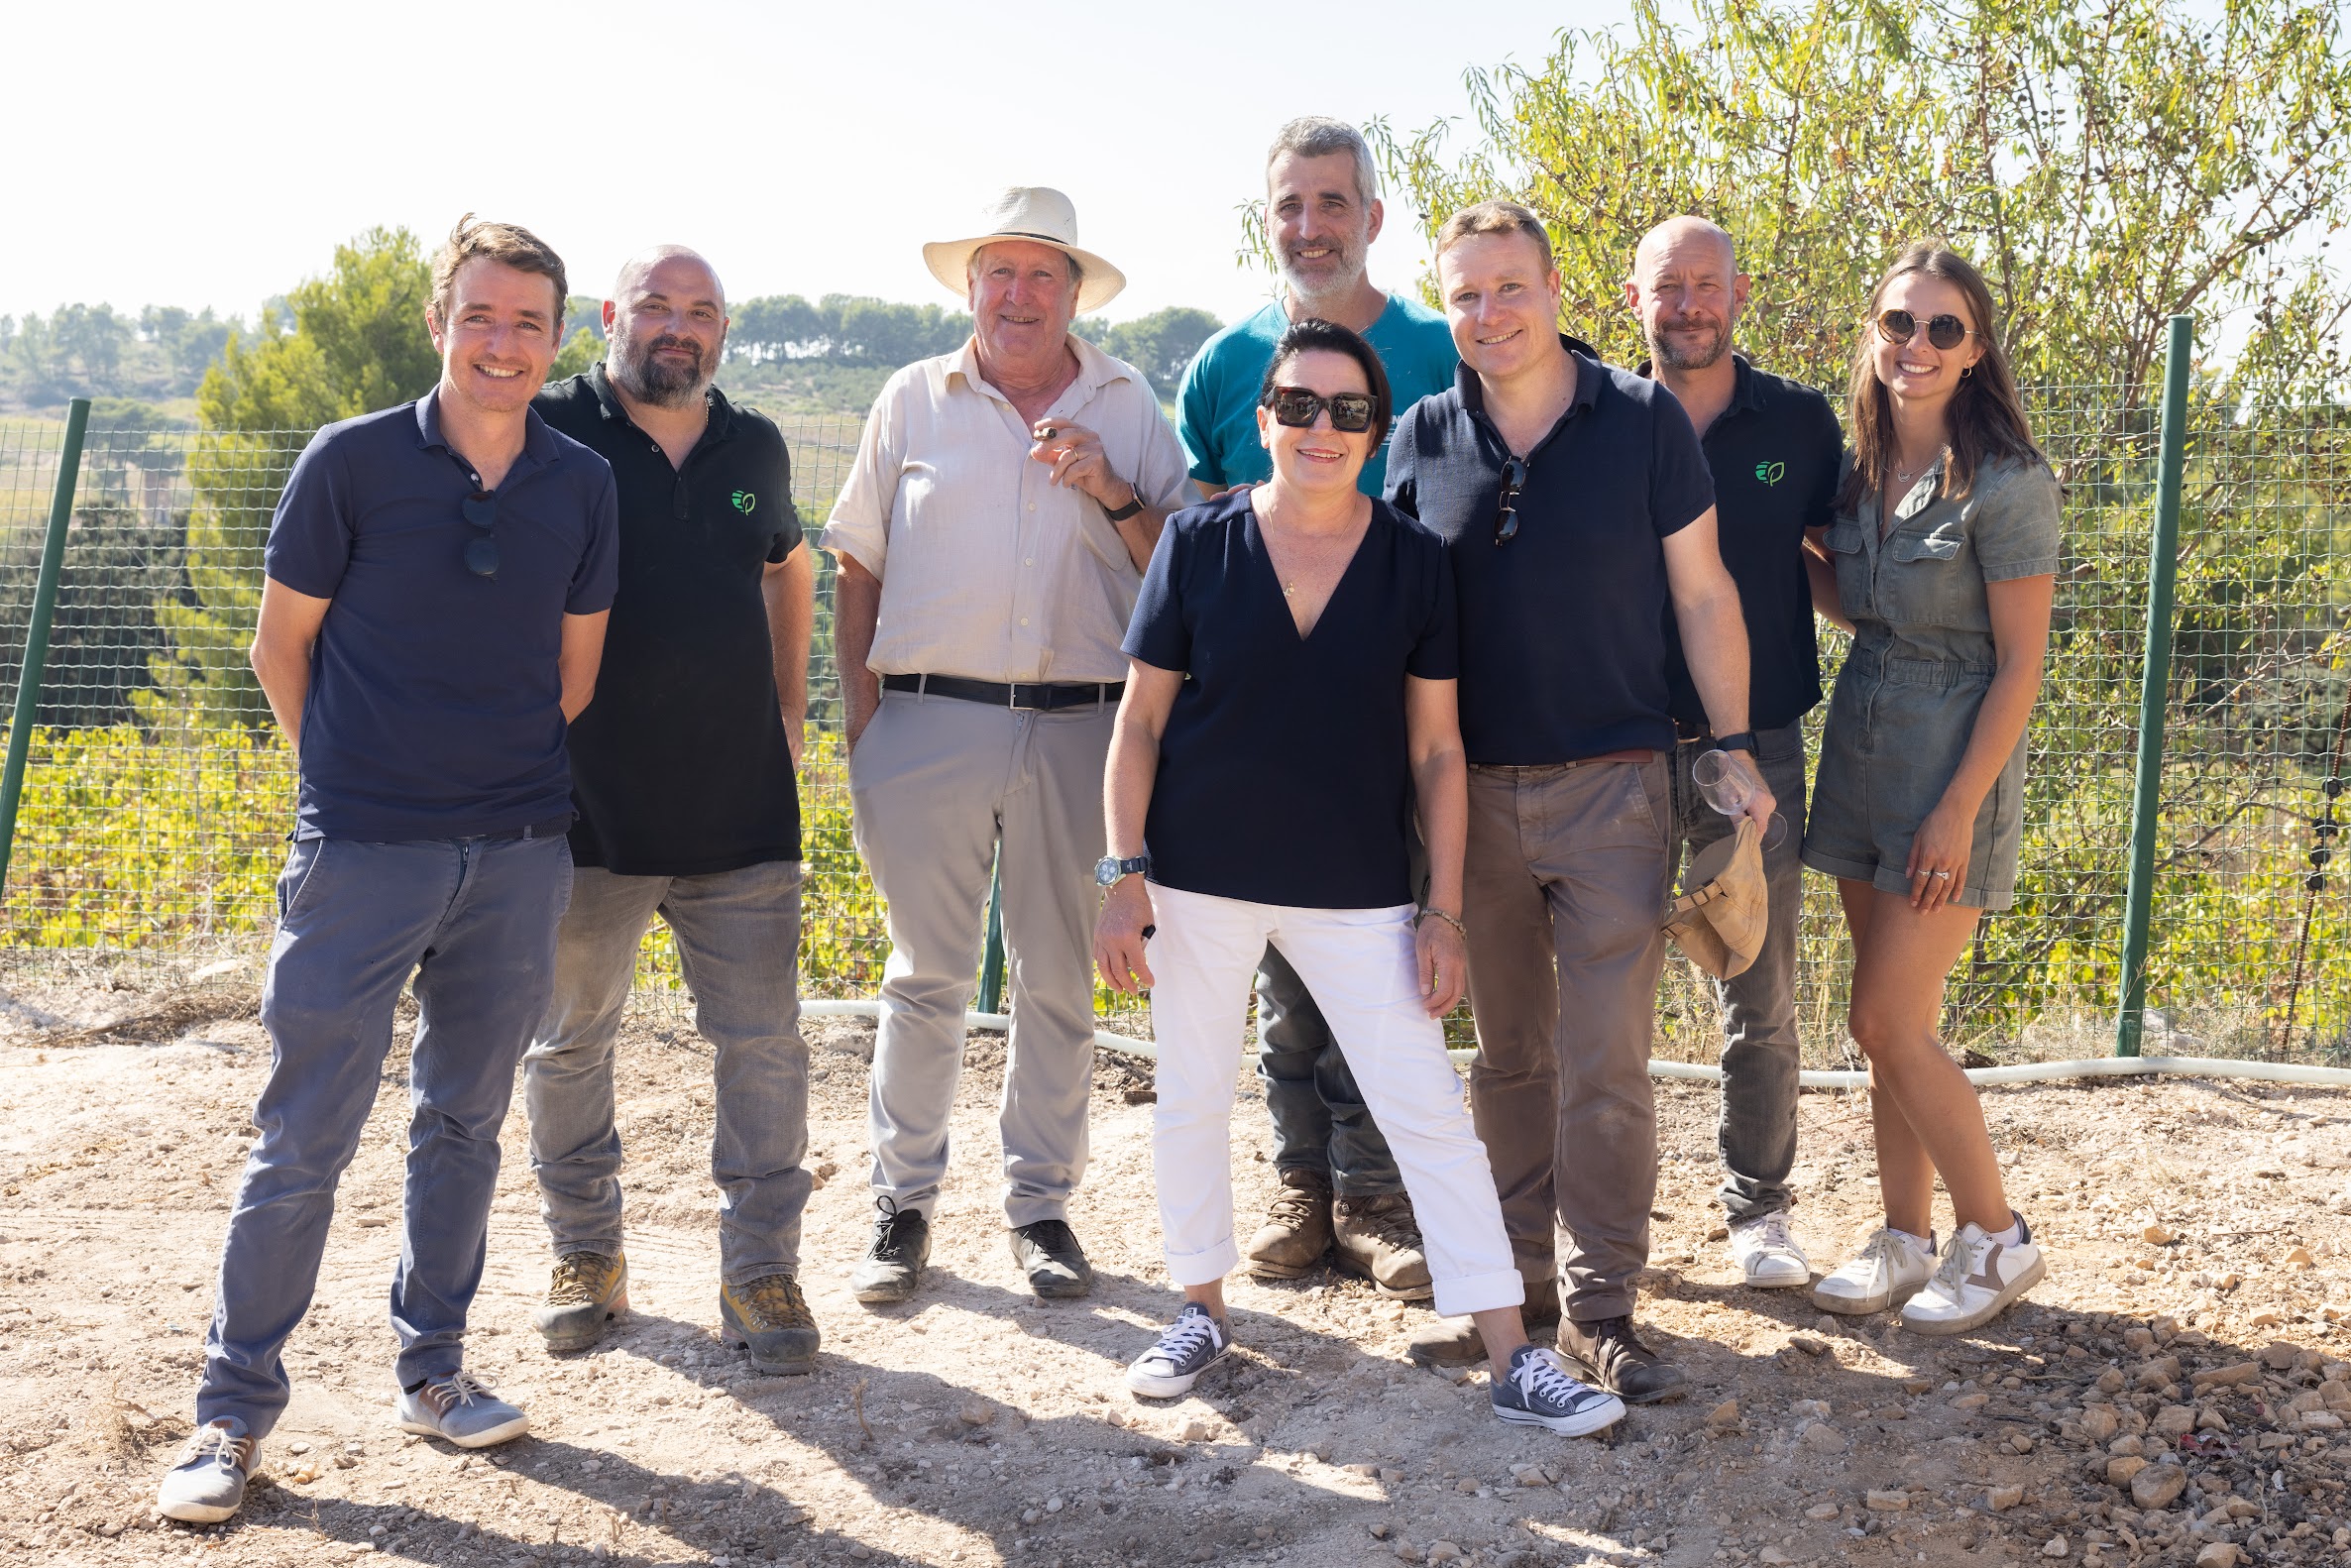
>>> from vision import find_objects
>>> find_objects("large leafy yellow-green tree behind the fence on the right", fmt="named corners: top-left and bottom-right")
top-left (1378, 0), bottom-right (2351, 1054)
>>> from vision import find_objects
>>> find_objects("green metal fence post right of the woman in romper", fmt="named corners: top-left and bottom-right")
top-left (2113, 315), bottom-right (2195, 1056)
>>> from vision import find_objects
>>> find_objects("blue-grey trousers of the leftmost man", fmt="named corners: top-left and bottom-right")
top-left (195, 830), bottom-right (571, 1436)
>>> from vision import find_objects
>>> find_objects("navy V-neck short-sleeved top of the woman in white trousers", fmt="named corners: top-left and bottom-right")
top-left (1124, 492), bottom-right (1455, 910)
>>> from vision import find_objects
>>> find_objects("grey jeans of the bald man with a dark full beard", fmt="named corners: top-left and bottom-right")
top-left (522, 860), bottom-right (811, 1284)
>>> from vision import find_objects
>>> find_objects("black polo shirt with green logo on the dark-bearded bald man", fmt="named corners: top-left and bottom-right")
top-left (536, 365), bottom-right (799, 877)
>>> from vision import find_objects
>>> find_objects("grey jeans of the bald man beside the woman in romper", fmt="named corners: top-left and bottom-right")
top-left (1674, 725), bottom-right (1803, 1220)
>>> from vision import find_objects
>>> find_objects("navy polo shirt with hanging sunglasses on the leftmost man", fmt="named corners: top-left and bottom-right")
top-left (266, 388), bottom-right (618, 843)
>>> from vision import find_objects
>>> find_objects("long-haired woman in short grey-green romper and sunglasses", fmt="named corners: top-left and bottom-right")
top-left (1803, 245), bottom-right (2058, 1333)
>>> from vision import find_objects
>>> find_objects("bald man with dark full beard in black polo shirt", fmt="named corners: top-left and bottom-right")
top-left (524, 245), bottom-right (818, 1373)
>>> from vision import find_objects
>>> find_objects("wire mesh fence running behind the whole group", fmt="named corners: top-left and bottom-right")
top-left (0, 386), bottom-right (2351, 1063)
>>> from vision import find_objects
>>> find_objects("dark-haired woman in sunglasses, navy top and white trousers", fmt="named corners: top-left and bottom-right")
top-left (1093, 320), bottom-right (1624, 1436)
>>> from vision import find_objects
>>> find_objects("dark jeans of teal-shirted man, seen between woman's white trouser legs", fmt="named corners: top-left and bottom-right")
top-left (1258, 948), bottom-right (1403, 1199)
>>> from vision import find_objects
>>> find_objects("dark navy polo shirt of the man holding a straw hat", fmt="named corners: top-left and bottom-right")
top-left (1387, 334), bottom-right (1714, 764)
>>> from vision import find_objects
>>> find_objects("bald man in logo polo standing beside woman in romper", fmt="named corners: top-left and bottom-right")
top-left (1624, 216), bottom-right (1846, 1288)
